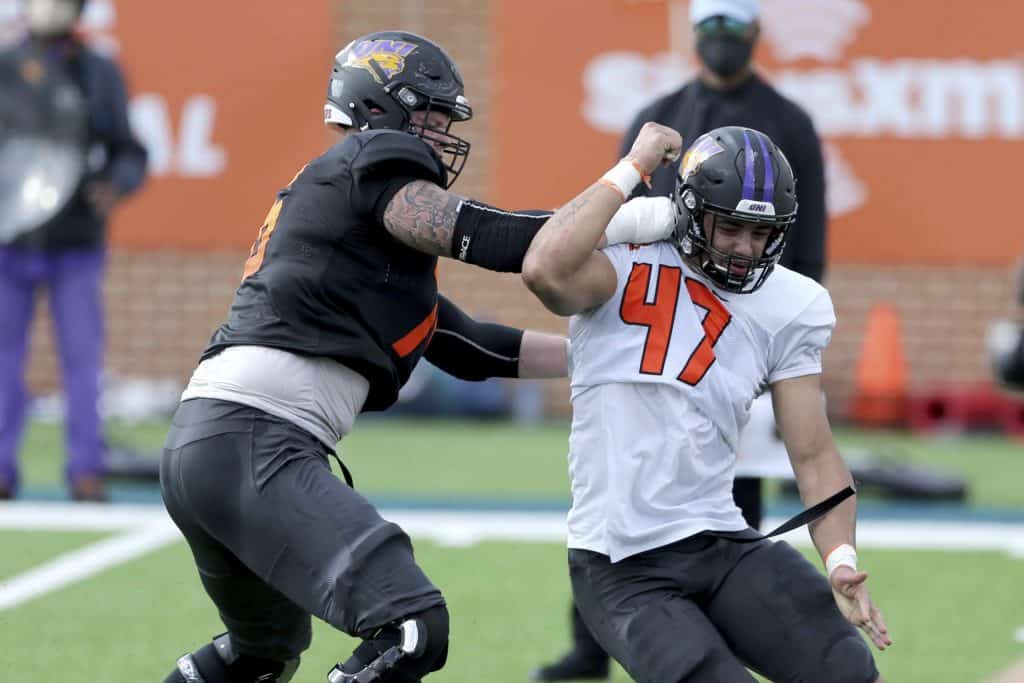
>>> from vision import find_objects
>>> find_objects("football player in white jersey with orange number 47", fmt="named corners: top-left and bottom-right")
top-left (523, 123), bottom-right (892, 683)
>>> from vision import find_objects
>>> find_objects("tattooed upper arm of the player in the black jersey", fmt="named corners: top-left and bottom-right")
top-left (384, 180), bottom-right (462, 256)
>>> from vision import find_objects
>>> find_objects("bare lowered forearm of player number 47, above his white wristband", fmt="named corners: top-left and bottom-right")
top-left (794, 447), bottom-right (857, 560)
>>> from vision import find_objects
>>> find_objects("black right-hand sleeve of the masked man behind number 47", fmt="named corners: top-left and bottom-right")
top-left (782, 115), bottom-right (828, 283)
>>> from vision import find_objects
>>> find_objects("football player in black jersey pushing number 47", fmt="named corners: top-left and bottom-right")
top-left (161, 32), bottom-right (675, 683)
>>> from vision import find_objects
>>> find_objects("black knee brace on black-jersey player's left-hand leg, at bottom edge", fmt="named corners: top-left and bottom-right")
top-left (164, 633), bottom-right (299, 683)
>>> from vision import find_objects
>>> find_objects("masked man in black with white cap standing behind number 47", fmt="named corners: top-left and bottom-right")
top-left (532, 0), bottom-right (827, 681)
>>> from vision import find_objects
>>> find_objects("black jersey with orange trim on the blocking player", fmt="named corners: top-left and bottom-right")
top-left (203, 130), bottom-right (445, 411)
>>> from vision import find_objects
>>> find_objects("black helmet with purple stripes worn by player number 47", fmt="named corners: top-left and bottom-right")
top-left (675, 126), bottom-right (797, 294)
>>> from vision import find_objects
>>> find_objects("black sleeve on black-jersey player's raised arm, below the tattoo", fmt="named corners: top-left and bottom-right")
top-left (452, 200), bottom-right (552, 272)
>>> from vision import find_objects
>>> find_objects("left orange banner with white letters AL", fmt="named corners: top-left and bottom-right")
top-left (0, 0), bottom-right (335, 249)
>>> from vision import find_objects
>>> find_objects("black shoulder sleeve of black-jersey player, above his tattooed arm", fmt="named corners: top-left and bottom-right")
top-left (351, 131), bottom-right (446, 223)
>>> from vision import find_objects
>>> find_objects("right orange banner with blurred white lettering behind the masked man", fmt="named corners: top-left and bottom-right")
top-left (492, 0), bottom-right (1024, 265)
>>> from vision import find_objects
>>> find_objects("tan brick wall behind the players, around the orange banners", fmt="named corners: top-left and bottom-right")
top-left (19, 0), bottom-right (1012, 414)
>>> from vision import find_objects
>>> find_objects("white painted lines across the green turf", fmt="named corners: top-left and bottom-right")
top-left (0, 502), bottom-right (1024, 610)
